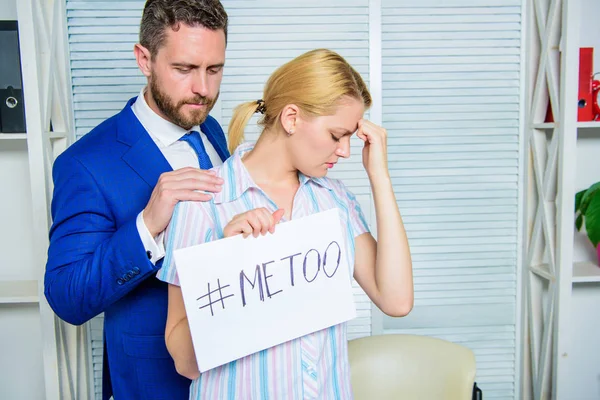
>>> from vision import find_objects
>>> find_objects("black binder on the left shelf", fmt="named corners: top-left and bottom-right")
top-left (0, 21), bottom-right (26, 133)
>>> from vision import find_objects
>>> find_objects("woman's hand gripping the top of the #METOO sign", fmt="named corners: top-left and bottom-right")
top-left (223, 207), bottom-right (284, 238)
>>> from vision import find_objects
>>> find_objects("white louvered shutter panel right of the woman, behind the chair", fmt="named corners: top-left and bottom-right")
top-left (382, 0), bottom-right (521, 399)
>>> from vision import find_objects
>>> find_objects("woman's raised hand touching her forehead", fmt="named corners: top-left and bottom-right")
top-left (356, 119), bottom-right (388, 177)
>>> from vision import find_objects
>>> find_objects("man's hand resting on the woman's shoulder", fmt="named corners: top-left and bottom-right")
top-left (143, 167), bottom-right (223, 237)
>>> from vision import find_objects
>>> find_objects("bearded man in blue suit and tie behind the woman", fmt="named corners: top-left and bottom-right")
top-left (44, 0), bottom-right (229, 400)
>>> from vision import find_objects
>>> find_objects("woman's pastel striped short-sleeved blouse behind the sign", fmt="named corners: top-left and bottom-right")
top-left (157, 144), bottom-right (369, 400)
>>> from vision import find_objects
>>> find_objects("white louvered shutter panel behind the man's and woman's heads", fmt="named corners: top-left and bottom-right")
top-left (67, 0), bottom-right (371, 399)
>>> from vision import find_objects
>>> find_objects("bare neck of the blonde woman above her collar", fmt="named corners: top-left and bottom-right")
top-left (242, 131), bottom-right (299, 188)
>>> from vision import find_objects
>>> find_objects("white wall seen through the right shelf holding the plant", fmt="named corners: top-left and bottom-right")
top-left (568, 0), bottom-right (600, 400)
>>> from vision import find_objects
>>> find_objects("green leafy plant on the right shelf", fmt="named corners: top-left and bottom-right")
top-left (575, 182), bottom-right (600, 247)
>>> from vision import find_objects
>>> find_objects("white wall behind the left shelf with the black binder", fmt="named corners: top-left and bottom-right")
top-left (0, 0), bottom-right (45, 400)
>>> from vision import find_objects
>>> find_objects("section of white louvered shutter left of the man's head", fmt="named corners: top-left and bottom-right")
top-left (67, 0), bottom-right (146, 138)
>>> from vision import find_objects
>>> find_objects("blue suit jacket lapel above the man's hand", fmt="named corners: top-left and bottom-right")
top-left (117, 97), bottom-right (173, 188)
